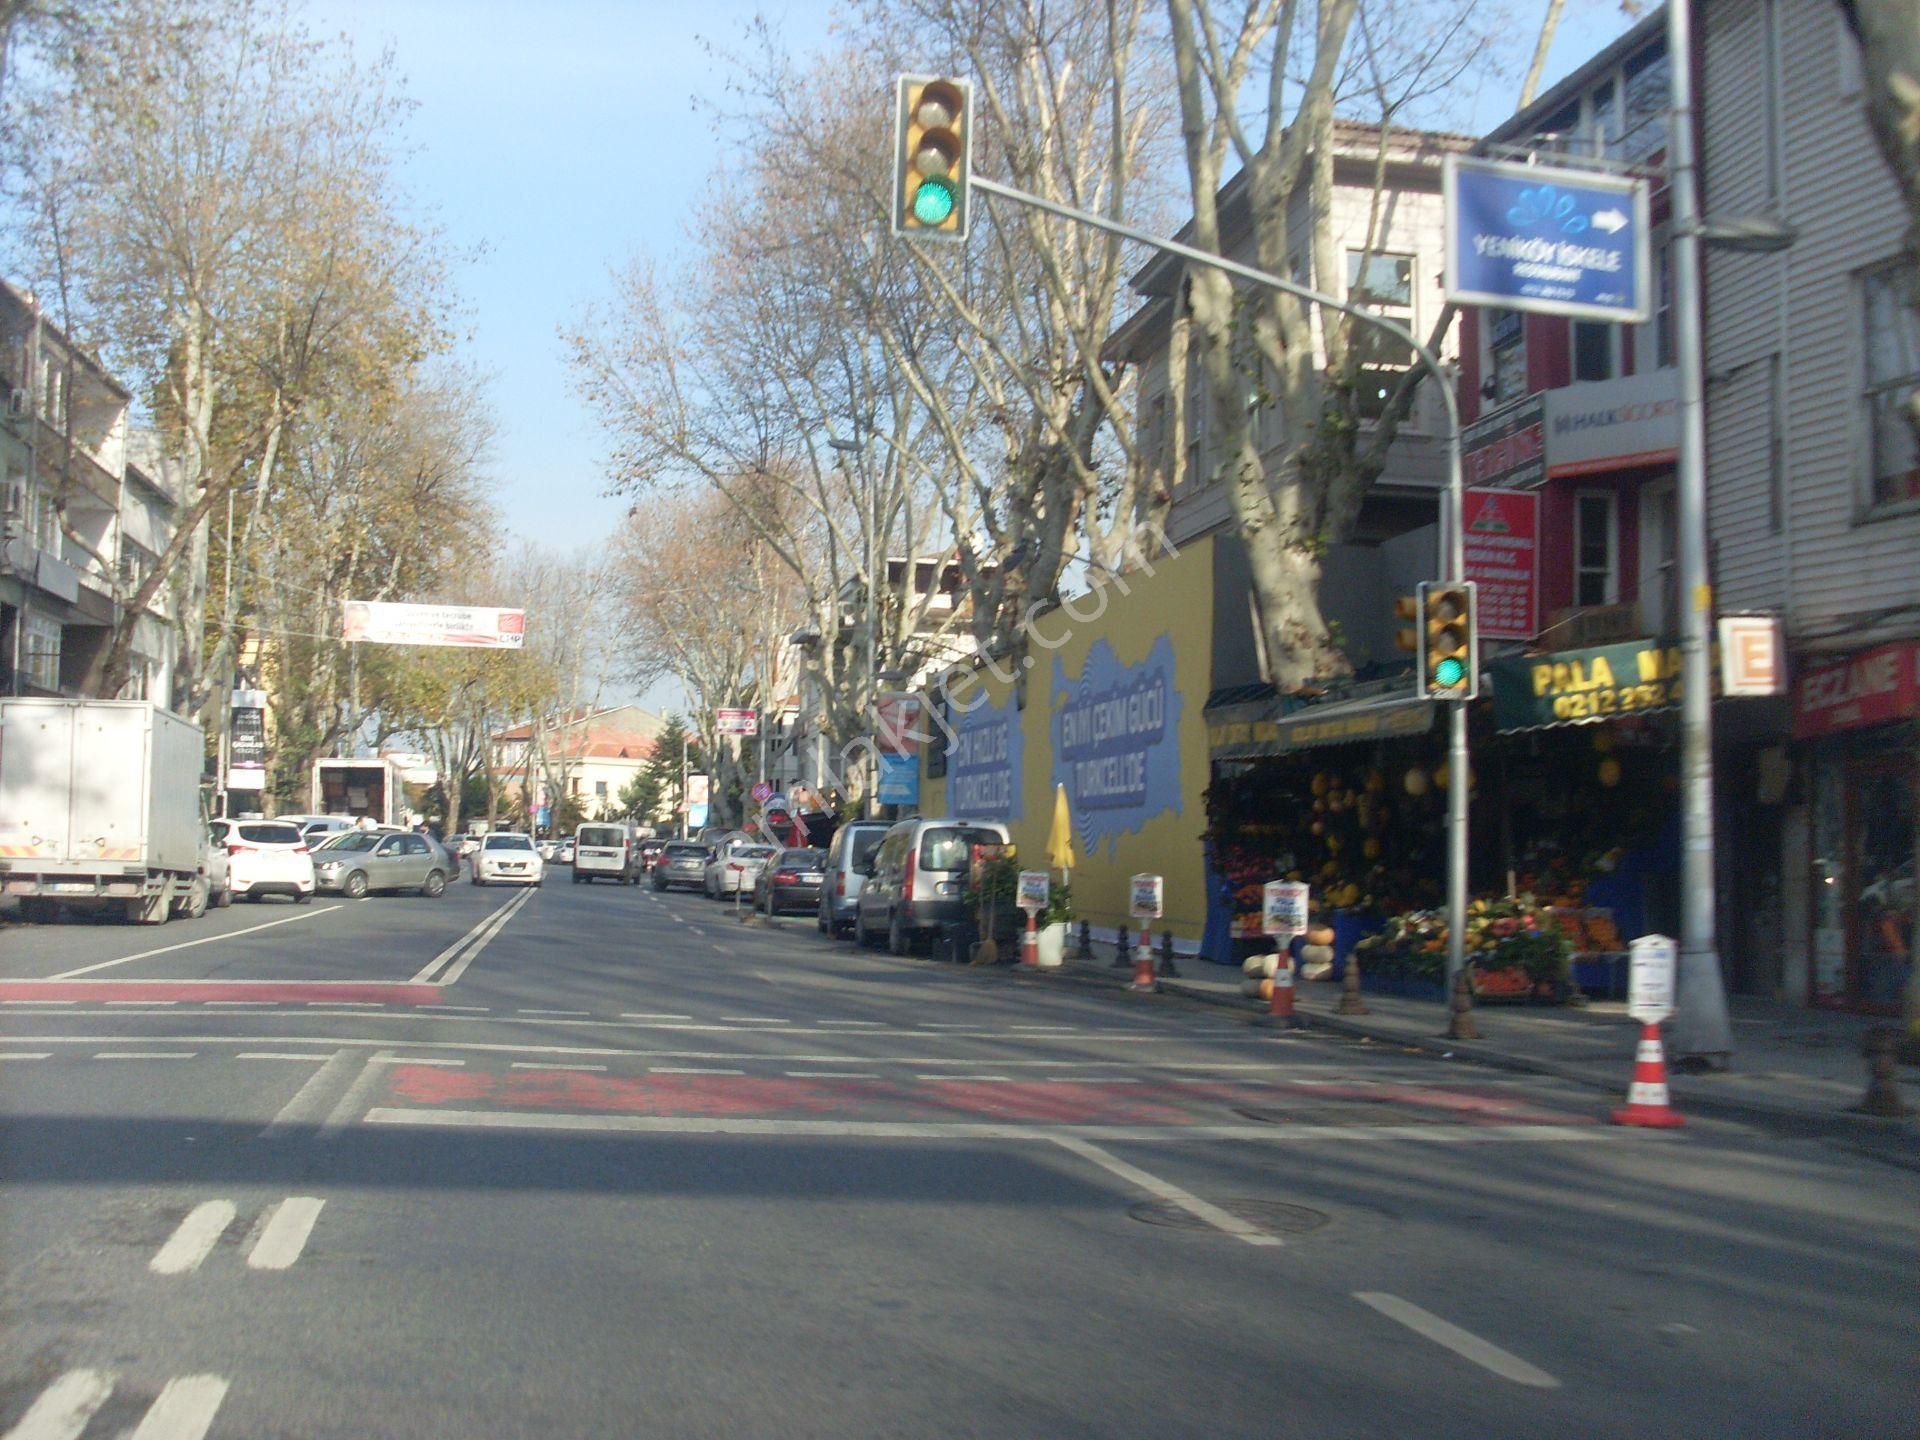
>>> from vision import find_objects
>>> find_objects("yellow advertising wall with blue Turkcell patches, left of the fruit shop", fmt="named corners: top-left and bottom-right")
top-left (920, 541), bottom-right (1213, 948)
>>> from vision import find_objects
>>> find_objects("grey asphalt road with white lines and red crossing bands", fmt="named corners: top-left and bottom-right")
top-left (0, 870), bottom-right (1920, 1440)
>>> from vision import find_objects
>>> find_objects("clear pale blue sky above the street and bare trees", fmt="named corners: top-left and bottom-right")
top-left (305, 0), bottom-right (1628, 568)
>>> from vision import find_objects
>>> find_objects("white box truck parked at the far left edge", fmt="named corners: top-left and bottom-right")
top-left (0, 699), bottom-right (207, 925)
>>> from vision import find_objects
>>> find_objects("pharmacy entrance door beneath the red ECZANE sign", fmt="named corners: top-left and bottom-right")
top-left (1841, 756), bottom-right (1914, 1014)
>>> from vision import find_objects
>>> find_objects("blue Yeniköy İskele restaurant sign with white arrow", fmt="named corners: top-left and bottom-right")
top-left (1446, 156), bottom-right (1653, 324)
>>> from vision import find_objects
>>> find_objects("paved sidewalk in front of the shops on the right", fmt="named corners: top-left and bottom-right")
top-left (1068, 943), bottom-right (1920, 1167)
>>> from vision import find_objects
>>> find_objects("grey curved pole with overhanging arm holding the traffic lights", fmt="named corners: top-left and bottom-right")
top-left (968, 173), bottom-right (1473, 995)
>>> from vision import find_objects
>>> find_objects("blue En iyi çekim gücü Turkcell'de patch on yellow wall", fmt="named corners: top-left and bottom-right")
top-left (1052, 636), bottom-right (1185, 854)
